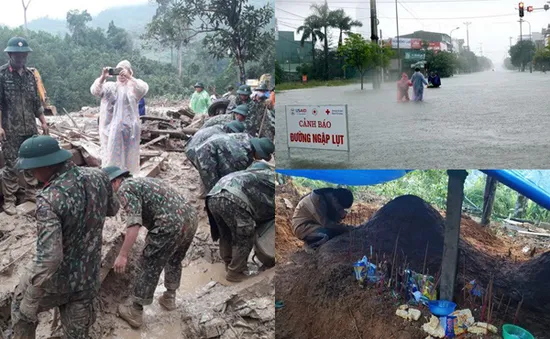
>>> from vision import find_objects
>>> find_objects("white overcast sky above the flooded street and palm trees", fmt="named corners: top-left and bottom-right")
top-left (275, 0), bottom-right (550, 64)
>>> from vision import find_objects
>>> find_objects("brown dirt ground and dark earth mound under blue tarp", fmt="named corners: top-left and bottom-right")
top-left (275, 185), bottom-right (550, 339)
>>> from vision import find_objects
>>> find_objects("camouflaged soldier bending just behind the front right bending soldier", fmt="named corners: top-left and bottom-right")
top-left (195, 133), bottom-right (275, 199)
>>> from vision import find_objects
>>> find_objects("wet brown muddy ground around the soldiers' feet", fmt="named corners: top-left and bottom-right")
top-left (0, 107), bottom-right (275, 339)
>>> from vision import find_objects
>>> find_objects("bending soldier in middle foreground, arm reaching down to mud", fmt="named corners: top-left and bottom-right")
top-left (103, 166), bottom-right (198, 328)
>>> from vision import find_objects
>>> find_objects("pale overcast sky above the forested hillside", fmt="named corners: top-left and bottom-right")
top-left (0, 0), bottom-right (147, 27)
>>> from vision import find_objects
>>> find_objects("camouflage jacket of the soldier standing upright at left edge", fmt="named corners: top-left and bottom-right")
top-left (0, 64), bottom-right (44, 137)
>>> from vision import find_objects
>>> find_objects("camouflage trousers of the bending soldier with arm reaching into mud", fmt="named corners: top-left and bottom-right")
top-left (132, 217), bottom-right (198, 306)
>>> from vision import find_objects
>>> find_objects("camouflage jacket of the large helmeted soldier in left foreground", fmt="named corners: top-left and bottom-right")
top-left (25, 161), bottom-right (119, 300)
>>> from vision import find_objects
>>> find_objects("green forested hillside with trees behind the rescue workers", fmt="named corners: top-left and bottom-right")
top-left (0, 0), bottom-right (274, 112)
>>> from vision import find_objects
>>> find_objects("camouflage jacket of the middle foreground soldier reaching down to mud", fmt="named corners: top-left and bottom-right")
top-left (118, 178), bottom-right (197, 234)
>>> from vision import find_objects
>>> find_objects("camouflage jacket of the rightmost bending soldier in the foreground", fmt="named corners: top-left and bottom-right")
top-left (207, 169), bottom-right (275, 224)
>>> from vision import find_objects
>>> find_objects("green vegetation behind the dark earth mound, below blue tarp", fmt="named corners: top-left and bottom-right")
top-left (293, 170), bottom-right (550, 222)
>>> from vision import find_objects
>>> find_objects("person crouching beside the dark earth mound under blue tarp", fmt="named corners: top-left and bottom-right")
top-left (292, 188), bottom-right (354, 253)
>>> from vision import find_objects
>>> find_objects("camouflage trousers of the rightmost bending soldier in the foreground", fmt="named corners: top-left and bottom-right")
top-left (206, 191), bottom-right (256, 273)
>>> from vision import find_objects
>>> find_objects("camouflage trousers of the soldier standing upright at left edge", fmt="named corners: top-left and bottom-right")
top-left (1, 136), bottom-right (38, 204)
